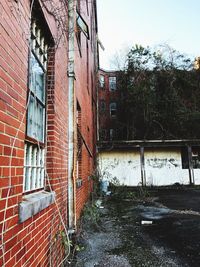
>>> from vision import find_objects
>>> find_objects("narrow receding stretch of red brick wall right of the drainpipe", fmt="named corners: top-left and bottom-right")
top-left (75, 1), bottom-right (97, 219)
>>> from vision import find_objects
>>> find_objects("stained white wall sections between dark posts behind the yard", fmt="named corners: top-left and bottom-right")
top-left (99, 148), bottom-right (200, 186)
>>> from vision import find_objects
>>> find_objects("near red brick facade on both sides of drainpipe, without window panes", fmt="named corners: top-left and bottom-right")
top-left (0, 0), bottom-right (97, 267)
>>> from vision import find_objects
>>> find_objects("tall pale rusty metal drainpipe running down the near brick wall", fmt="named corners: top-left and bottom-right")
top-left (68, 0), bottom-right (75, 233)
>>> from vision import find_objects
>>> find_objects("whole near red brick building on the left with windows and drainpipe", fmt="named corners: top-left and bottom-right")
top-left (0, 0), bottom-right (98, 267)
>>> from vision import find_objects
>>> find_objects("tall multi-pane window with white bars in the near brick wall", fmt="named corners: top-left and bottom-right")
top-left (24, 17), bottom-right (48, 192)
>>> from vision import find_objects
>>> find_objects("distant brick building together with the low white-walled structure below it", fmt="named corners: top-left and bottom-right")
top-left (98, 69), bottom-right (200, 186)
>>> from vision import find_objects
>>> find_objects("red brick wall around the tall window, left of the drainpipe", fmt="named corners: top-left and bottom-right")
top-left (0, 0), bottom-right (68, 267)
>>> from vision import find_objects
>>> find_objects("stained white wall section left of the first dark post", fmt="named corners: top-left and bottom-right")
top-left (98, 151), bottom-right (141, 186)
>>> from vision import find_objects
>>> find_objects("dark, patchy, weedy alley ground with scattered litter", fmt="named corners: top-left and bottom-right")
top-left (70, 186), bottom-right (200, 267)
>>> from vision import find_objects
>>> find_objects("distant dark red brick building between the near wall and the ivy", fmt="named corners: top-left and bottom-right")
top-left (98, 69), bottom-right (121, 141)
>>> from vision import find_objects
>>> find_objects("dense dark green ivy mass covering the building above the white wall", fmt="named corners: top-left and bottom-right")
top-left (118, 45), bottom-right (200, 140)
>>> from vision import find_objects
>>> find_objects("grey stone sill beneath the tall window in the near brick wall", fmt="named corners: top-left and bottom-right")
top-left (19, 191), bottom-right (55, 223)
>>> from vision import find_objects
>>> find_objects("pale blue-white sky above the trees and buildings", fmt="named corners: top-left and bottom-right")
top-left (97, 0), bottom-right (200, 70)
